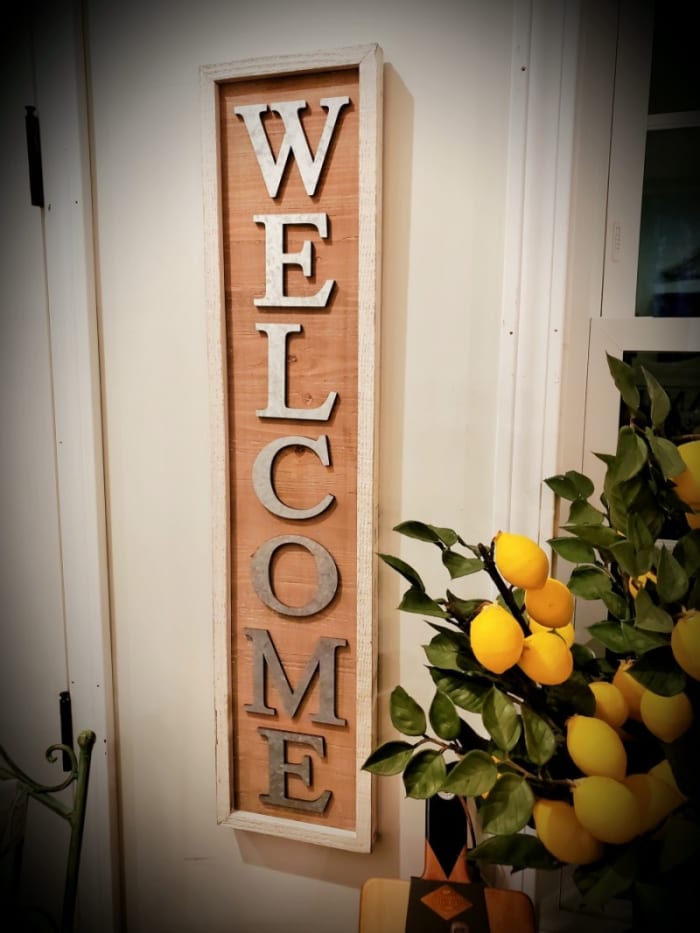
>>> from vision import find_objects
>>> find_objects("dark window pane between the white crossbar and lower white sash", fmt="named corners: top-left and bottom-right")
top-left (635, 127), bottom-right (700, 317)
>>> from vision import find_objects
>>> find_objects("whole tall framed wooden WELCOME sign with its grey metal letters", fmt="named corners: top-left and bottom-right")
top-left (202, 46), bottom-right (381, 851)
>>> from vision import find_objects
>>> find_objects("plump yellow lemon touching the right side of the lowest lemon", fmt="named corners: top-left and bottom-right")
top-left (574, 775), bottom-right (642, 845)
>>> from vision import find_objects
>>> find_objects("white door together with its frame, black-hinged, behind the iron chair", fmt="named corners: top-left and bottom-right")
top-left (0, 4), bottom-right (114, 931)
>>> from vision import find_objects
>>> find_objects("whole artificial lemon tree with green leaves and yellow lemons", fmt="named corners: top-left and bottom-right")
top-left (364, 357), bottom-right (700, 920)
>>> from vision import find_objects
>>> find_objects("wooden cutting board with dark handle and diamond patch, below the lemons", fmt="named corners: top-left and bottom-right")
top-left (359, 795), bottom-right (537, 933)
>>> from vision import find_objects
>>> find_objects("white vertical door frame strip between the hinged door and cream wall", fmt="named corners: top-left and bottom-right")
top-left (31, 0), bottom-right (120, 933)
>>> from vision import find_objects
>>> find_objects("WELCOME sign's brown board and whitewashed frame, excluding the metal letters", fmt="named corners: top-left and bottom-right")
top-left (201, 47), bottom-right (381, 851)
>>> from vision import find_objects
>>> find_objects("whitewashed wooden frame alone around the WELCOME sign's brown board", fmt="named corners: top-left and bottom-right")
top-left (200, 45), bottom-right (383, 852)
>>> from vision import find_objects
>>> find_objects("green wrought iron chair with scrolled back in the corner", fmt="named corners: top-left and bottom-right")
top-left (0, 730), bottom-right (96, 933)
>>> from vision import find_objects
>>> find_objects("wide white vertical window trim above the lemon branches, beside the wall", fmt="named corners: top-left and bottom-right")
top-left (493, 0), bottom-right (579, 539)
